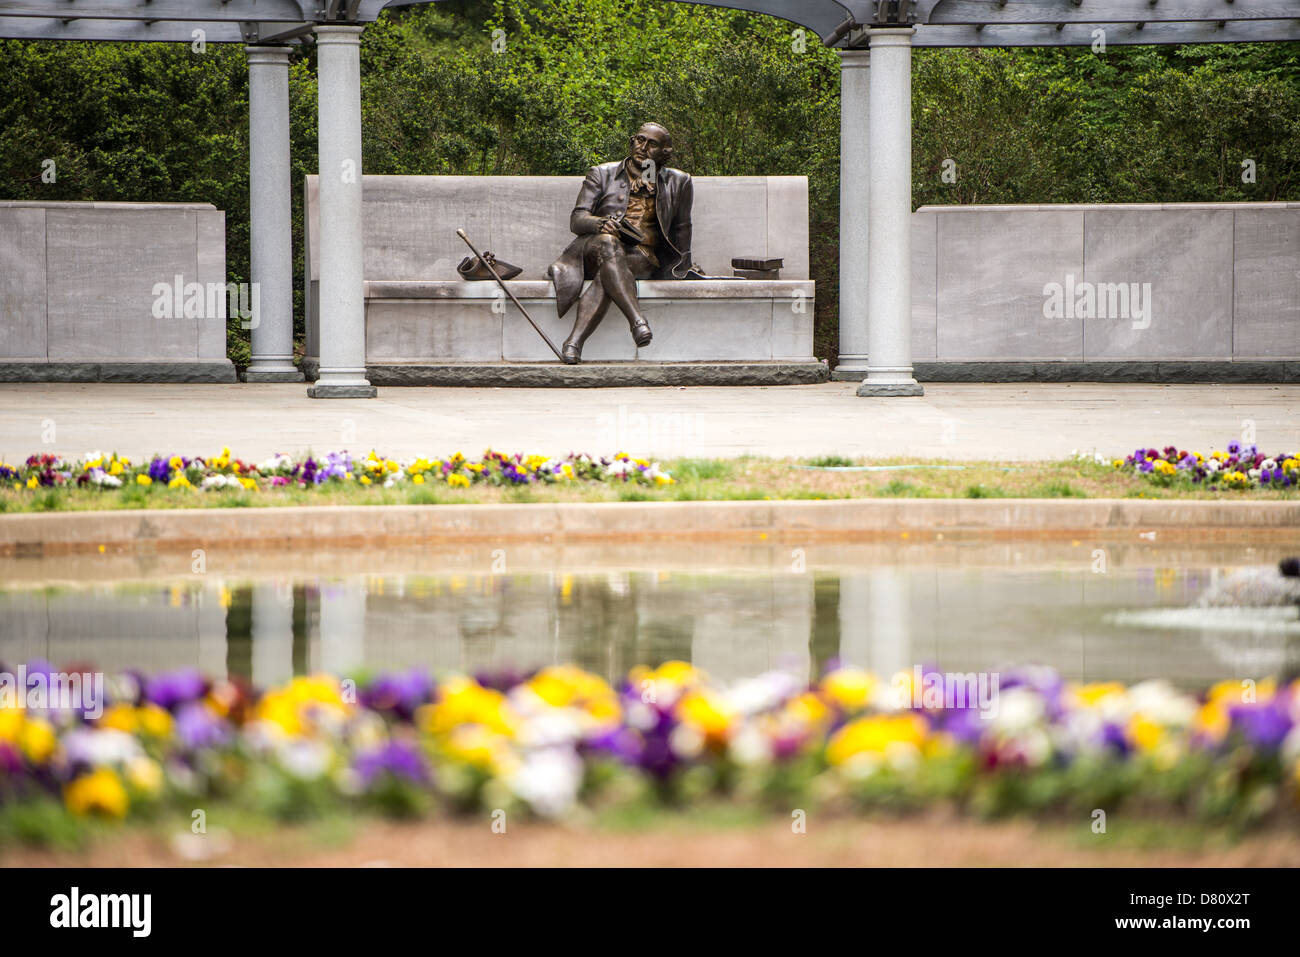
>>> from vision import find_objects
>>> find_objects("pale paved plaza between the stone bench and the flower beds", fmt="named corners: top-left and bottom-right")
top-left (0, 382), bottom-right (1300, 462)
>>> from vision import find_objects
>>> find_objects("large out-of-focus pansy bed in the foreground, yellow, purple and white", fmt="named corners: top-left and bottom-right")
top-left (0, 662), bottom-right (1300, 843)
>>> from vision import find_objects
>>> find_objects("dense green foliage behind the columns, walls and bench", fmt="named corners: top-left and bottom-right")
top-left (0, 0), bottom-right (1300, 361)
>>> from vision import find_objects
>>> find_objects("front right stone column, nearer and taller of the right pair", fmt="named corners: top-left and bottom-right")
top-left (858, 26), bottom-right (924, 395)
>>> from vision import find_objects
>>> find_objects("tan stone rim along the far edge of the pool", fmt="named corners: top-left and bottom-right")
top-left (0, 498), bottom-right (1300, 558)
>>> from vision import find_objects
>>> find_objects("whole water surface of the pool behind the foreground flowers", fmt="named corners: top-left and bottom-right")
top-left (0, 542), bottom-right (1300, 688)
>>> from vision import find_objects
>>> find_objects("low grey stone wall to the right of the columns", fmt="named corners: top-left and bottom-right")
top-left (911, 203), bottom-right (1300, 381)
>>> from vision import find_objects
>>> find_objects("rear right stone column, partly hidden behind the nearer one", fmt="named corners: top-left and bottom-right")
top-left (831, 49), bottom-right (871, 382)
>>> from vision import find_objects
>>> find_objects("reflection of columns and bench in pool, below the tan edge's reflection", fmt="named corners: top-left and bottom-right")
top-left (0, 562), bottom-right (1300, 687)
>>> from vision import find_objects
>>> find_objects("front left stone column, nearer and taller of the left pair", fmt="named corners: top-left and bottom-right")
top-left (307, 26), bottom-right (376, 399)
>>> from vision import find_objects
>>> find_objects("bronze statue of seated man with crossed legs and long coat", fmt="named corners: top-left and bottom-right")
top-left (547, 124), bottom-right (694, 364)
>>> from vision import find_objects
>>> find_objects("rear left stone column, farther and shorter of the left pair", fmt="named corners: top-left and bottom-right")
top-left (244, 47), bottom-right (303, 382)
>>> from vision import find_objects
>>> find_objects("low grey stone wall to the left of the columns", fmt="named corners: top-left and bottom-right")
top-left (0, 202), bottom-right (235, 382)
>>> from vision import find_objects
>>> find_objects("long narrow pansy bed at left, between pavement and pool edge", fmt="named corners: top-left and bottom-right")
top-left (0, 447), bottom-right (673, 493)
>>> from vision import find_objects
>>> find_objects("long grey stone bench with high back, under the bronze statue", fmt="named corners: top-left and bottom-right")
top-left (304, 176), bottom-right (827, 385)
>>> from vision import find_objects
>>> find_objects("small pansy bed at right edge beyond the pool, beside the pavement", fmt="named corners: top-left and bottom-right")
top-left (1112, 441), bottom-right (1300, 489)
